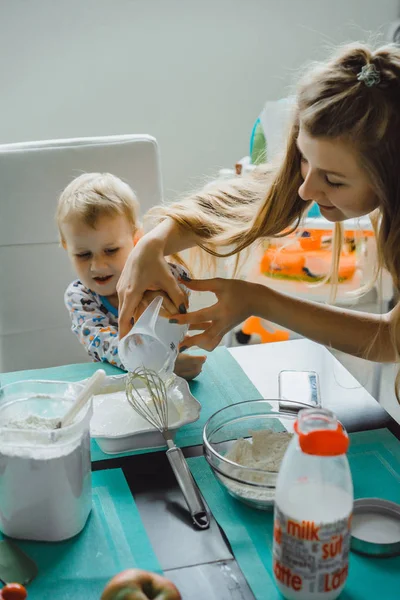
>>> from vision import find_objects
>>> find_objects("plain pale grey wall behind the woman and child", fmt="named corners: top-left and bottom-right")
top-left (0, 0), bottom-right (399, 197)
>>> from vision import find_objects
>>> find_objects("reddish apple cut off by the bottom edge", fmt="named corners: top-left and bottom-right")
top-left (101, 569), bottom-right (182, 600)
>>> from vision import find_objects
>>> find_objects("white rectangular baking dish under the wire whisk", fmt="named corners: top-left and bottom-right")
top-left (90, 375), bottom-right (201, 454)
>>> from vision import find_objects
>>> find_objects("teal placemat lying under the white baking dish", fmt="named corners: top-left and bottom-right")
top-left (0, 346), bottom-right (261, 462)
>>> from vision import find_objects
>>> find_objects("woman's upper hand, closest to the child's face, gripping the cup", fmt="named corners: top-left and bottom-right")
top-left (117, 236), bottom-right (187, 339)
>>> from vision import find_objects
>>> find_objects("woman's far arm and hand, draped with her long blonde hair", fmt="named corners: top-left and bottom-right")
top-left (117, 163), bottom-right (284, 337)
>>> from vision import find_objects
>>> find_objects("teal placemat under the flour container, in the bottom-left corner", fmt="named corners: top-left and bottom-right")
top-left (1, 469), bottom-right (162, 600)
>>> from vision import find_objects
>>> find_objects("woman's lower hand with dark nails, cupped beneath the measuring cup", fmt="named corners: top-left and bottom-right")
top-left (170, 278), bottom-right (258, 350)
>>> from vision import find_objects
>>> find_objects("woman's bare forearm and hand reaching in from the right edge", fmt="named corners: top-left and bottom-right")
top-left (172, 279), bottom-right (400, 362)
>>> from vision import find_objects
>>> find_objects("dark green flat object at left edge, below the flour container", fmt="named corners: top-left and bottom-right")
top-left (0, 534), bottom-right (38, 585)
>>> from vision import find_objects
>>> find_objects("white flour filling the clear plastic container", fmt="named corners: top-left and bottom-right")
top-left (0, 415), bottom-right (91, 541)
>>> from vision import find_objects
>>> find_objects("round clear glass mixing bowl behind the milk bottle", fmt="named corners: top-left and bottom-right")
top-left (203, 400), bottom-right (310, 510)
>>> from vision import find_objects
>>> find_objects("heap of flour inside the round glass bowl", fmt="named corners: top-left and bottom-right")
top-left (223, 430), bottom-right (292, 508)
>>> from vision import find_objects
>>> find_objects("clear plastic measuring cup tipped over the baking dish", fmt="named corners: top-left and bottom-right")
top-left (118, 296), bottom-right (188, 379)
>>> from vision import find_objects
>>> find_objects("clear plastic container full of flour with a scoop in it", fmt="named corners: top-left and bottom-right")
top-left (0, 381), bottom-right (92, 542)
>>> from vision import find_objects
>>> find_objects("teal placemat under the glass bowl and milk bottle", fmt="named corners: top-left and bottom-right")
top-left (188, 429), bottom-right (400, 600)
